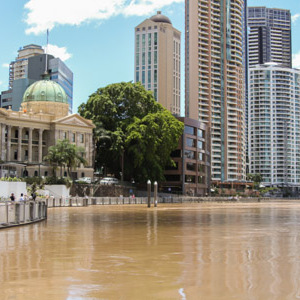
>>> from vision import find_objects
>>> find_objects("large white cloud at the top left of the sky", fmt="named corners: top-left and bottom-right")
top-left (25, 0), bottom-right (184, 34)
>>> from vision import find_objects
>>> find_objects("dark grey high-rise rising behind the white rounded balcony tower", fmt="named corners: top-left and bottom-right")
top-left (248, 7), bottom-right (292, 68)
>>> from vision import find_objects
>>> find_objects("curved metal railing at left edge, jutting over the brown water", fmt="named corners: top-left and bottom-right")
top-left (0, 201), bottom-right (47, 228)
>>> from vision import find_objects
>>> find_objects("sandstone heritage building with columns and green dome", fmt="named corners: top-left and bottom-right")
top-left (0, 80), bottom-right (95, 178)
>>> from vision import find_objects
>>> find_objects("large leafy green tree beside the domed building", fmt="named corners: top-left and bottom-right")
top-left (79, 82), bottom-right (183, 181)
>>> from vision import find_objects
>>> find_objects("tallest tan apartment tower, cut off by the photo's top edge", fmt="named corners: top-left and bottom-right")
top-left (185, 0), bottom-right (246, 182)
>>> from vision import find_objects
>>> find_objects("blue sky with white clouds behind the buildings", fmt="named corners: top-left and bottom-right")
top-left (0, 0), bottom-right (300, 112)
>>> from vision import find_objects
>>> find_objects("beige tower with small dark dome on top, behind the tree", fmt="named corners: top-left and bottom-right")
top-left (134, 11), bottom-right (181, 115)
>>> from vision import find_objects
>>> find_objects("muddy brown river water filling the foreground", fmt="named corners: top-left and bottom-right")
top-left (0, 201), bottom-right (300, 300)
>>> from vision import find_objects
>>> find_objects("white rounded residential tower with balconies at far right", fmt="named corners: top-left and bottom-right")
top-left (249, 63), bottom-right (300, 189)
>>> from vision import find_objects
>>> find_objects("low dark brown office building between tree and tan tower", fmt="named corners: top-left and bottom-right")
top-left (161, 117), bottom-right (211, 196)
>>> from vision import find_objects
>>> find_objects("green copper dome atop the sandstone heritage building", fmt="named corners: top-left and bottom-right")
top-left (23, 80), bottom-right (68, 104)
